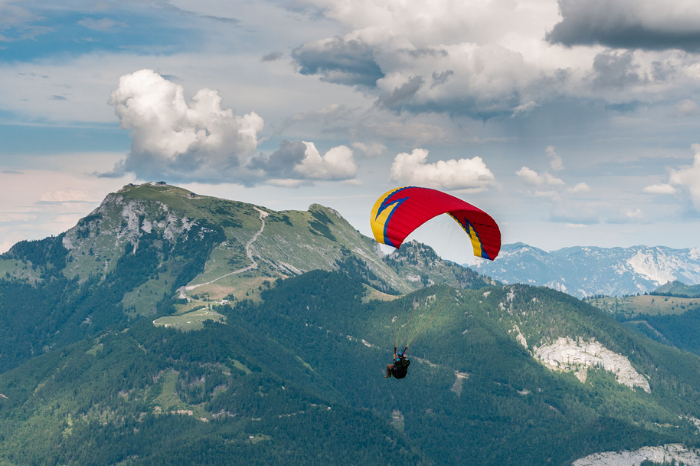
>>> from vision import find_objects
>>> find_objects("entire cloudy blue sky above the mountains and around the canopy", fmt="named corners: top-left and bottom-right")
top-left (0, 0), bottom-right (700, 263)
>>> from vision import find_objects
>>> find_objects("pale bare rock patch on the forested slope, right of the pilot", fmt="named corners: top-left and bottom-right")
top-left (535, 337), bottom-right (651, 393)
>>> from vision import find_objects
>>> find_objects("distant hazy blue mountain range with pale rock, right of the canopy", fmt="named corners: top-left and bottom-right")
top-left (465, 243), bottom-right (700, 298)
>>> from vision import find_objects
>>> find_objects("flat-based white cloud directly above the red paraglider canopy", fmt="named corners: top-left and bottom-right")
top-left (390, 149), bottom-right (495, 192)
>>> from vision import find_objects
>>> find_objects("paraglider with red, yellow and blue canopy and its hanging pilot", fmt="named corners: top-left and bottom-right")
top-left (370, 186), bottom-right (501, 379)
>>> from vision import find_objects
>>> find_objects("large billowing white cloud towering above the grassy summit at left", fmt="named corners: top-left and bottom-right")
top-left (109, 69), bottom-right (263, 183)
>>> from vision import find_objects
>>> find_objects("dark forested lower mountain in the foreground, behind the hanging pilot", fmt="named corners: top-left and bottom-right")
top-left (6, 270), bottom-right (700, 465)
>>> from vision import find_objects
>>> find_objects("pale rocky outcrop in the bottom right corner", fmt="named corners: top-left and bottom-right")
top-left (572, 444), bottom-right (700, 466)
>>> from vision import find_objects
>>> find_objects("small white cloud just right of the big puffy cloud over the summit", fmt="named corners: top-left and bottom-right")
top-left (294, 141), bottom-right (357, 180)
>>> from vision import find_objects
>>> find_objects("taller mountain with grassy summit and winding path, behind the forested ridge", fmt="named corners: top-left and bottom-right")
top-left (0, 183), bottom-right (495, 371)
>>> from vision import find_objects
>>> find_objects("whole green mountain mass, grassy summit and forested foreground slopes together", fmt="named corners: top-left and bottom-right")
top-left (0, 185), bottom-right (700, 466)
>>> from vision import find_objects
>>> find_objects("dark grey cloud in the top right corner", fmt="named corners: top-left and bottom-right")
top-left (546, 0), bottom-right (700, 52)
